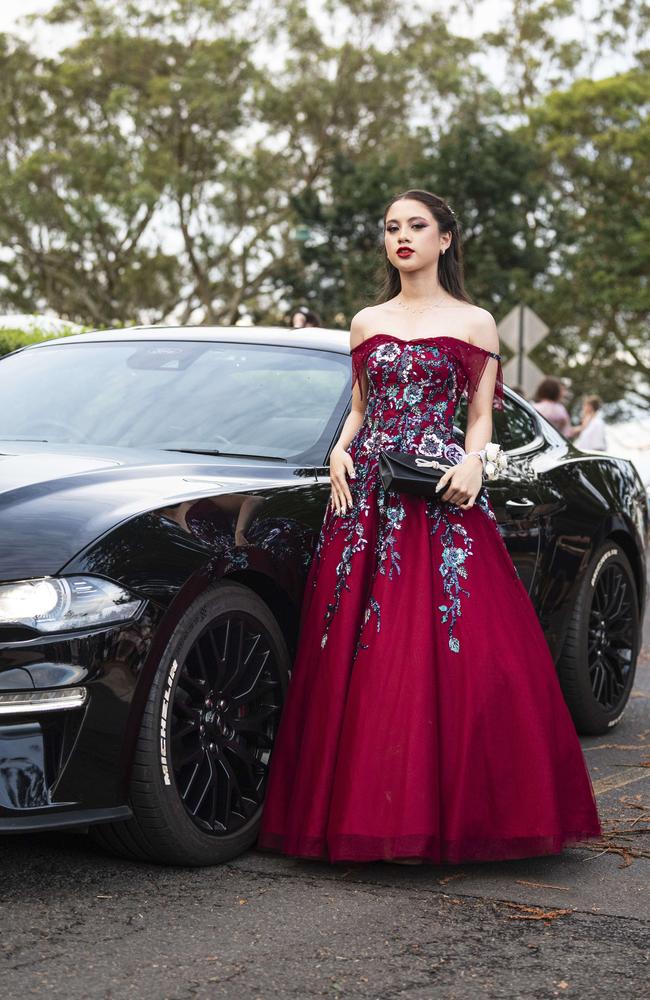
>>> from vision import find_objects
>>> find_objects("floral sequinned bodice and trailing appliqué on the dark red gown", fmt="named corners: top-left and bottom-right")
top-left (313, 334), bottom-right (503, 657)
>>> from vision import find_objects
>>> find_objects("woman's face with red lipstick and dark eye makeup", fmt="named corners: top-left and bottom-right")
top-left (384, 198), bottom-right (451, 271)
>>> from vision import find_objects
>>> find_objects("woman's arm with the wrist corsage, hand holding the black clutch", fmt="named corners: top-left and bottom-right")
top-left (438, 309), bottom-right (499, 510)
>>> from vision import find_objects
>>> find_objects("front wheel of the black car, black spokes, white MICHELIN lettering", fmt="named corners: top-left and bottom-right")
top-left (93, 582), bottom-right (291, 866)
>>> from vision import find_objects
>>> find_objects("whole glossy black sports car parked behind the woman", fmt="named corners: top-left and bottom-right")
top-left (0, 328), bottom-right (648, 864)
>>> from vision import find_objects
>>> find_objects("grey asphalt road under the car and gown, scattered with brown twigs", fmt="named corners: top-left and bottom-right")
top-left (0, 612), bottom-right (650, 1000)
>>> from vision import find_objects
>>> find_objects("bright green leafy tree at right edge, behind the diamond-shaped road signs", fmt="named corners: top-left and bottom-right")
top-left (528, 58), bottom-right (650, 405)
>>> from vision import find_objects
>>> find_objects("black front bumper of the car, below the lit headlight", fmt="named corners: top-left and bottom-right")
top-left (0, 604), bottom-right (161, 833)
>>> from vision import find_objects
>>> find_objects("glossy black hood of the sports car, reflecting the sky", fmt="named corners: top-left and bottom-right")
top-left (0, 442), bottom-right (297, 580)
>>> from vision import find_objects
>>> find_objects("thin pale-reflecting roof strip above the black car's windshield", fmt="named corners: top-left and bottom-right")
top-left (27, 326), bottom-right (350, 354)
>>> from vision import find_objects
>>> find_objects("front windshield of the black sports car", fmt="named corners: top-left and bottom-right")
top-left (0, 341), bottom-right (350, 464)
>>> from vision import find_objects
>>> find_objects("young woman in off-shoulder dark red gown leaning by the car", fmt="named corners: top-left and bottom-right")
top-left (258, 191), bottom-right (601, 863)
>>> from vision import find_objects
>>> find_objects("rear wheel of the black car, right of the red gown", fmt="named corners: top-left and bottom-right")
top-left (557, 541), bottom-right (640, 736)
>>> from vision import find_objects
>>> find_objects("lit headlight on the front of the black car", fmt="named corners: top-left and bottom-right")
top-left (0, 576), bottom-right (144, 632)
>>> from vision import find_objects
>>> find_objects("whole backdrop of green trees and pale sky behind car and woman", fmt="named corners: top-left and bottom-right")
top-left (0, 0), bottom-right (650, 401)
